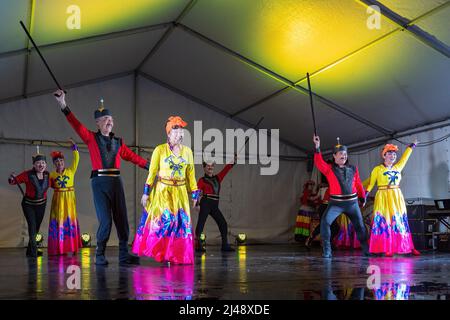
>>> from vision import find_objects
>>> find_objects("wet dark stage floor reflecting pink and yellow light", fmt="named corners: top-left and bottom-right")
top-left (0, 244), bottom-right (450, 300)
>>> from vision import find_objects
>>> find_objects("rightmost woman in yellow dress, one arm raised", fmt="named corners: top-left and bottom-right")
top-left (367, 139), bottom-right (420, 257)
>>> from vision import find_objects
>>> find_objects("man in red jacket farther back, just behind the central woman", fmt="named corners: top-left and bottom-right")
top-left (195, 155), bottom-right (236, 251)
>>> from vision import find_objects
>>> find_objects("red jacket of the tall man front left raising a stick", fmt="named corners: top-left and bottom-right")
top-left (63, 107), bottom-right (149, 170)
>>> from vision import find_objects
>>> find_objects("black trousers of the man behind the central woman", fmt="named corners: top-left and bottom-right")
top-left (195, 198), bottom-right (228, 246)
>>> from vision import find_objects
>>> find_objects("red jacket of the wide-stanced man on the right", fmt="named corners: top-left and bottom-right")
top-left (314, 152), bottom-right (365, 198)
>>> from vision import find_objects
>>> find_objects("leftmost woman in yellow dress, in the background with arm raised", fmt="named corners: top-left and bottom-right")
top-left (48, 140), bottom-right (82, 255)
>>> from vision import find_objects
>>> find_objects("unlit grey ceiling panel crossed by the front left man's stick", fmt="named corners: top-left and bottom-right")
top-left (27, 30), bottom-right (164, 92)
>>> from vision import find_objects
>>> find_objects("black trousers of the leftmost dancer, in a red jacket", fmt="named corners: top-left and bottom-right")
top-left (22, 199), bottom-right (47, 257)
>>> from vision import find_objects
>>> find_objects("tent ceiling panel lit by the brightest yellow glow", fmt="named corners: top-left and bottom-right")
top-left (183, 0), bottom-right (397, 81)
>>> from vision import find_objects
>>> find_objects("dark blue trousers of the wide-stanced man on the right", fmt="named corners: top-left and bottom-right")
top-left (320, 200), bottom-right (367, 246)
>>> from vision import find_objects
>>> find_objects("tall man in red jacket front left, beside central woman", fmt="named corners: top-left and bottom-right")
top-left (55, 90), bottom-right (149, 265)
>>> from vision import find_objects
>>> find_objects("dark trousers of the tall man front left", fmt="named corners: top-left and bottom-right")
top-left (91, 177), bottom-right (130, 255)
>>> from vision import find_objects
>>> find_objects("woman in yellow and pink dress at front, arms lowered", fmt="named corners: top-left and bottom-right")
top-left (132, 116), bottom-right (199, 264)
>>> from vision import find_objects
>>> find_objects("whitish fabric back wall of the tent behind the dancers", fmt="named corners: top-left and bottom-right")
top-left (0, 76), bottom-right (307, 247)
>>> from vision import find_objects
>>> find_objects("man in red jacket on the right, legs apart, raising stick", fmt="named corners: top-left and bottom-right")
top-left (313, 135), bottom-right (370, 258)
